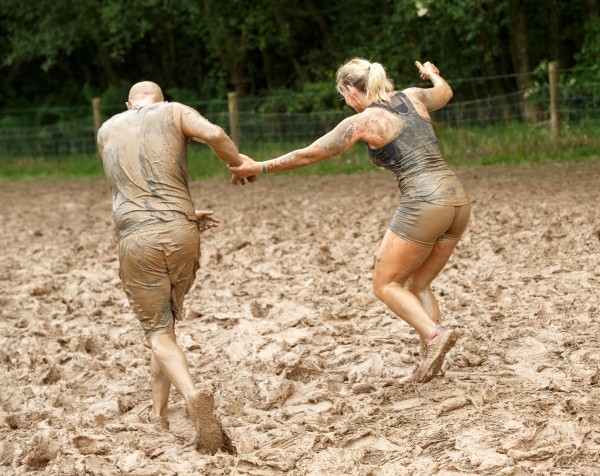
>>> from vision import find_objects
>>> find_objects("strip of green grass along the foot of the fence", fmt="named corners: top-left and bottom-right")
top-left (0, 121), bottom-right (600, 180)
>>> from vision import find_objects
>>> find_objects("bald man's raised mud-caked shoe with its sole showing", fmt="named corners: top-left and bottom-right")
top-left (186, 390), bottom-right (225, 455)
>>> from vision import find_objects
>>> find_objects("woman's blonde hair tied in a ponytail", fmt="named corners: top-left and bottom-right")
top-left (335, 58), bottom-right (394, 103)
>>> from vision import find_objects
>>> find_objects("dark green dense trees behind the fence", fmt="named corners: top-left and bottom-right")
top-left (0, 0), bottom-right (600, 110)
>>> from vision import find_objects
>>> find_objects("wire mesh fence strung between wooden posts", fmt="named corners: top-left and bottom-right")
top-left (0, 82), bottom-right (600, 159)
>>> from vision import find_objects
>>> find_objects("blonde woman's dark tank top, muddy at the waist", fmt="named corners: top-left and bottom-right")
top-left (369, 92), bottom-right (469, 206)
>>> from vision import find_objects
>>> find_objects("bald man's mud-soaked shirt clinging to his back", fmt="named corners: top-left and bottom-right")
top-left (98, 102), bottom-right (196, 239)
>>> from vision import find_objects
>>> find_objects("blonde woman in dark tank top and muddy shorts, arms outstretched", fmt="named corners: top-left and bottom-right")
top-left (229, 58), bottom-right (470, 382)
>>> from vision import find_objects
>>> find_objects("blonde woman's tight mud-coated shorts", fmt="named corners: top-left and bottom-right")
top-left (390, 200), bottom-right (471, 246)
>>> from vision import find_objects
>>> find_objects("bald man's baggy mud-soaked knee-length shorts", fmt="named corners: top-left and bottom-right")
top-left (119, 220), bottom-right (200, 338)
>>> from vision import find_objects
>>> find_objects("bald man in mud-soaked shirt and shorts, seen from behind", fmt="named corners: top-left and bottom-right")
top-left (98, 81), bottom-right (250, 454)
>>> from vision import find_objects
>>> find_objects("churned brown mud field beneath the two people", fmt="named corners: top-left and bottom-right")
top-left (0, 161), bottom-right (600, 476)
